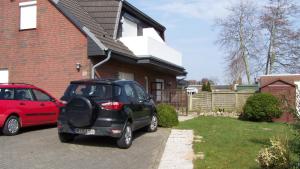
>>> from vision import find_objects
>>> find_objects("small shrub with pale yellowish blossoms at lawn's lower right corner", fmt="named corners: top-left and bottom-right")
top-left (257, 138), bottom-right (290, 169)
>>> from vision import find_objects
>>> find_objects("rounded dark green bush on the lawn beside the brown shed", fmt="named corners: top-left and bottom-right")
top-left (242, 93), bottom-right (282, 121)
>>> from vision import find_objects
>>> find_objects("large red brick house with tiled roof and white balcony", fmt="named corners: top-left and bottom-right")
top-left (0, 0), bottom-right (186, 99)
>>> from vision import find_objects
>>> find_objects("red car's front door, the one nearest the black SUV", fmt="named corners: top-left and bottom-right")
top-left (32, 89), bottom-right (59, 124)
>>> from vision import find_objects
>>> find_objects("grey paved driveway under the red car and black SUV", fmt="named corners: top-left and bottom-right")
top-left (0, 127), bottom-right (170, 169)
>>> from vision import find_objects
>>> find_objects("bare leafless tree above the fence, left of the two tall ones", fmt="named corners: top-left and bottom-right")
top-left (216, 0), bottom-right (259, 84)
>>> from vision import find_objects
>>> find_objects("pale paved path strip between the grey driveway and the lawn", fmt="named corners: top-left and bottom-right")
top-left (159, 129), bottom-right (194, 169)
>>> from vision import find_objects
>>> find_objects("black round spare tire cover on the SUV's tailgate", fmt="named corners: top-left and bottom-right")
top-left (66, 97), bottom-right (95, 127)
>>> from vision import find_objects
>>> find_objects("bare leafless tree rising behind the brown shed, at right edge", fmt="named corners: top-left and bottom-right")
top-left (261, 0), bottom-right (300, 74)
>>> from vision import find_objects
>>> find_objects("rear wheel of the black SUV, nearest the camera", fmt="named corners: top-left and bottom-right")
top-left (117, 123), bottom-right (133, 149)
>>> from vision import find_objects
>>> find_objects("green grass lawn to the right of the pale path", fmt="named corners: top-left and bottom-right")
top-left (178, 117), bottom-right (292, 169)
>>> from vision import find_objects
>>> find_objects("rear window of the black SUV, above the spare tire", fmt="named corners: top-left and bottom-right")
top-left (65, 84), bottom-right (112, 99)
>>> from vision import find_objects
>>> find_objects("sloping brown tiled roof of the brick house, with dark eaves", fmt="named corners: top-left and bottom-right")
top-left (49, 0), bottom-right (186, 75)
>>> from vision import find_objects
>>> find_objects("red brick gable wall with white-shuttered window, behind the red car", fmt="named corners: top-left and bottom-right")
top-left (0, 0), bottom-right (91, 97)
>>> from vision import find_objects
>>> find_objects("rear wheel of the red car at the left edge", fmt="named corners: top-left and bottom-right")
top-left (2, 116), bottom-right (21, 136)
